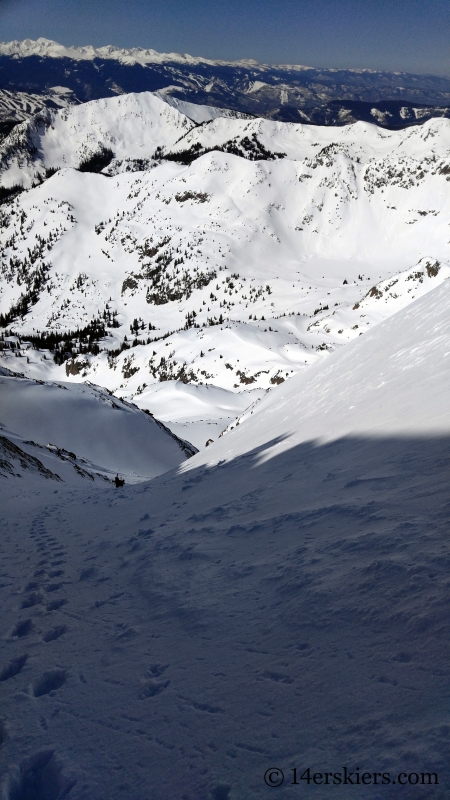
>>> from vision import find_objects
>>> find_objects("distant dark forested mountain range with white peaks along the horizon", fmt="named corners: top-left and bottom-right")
top-left (0, 38), bottom-right (450, 132)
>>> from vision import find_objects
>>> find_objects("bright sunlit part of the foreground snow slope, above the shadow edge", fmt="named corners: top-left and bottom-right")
top-left (199, 274), bottom-right (450, 450)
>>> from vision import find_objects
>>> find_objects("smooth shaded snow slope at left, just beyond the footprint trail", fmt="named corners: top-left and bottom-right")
top-left (0, 369), bottom-right (195, 483)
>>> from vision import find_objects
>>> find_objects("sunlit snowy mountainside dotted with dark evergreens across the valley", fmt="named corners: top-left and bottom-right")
top-left (0, 93), bottom-right (450, 438)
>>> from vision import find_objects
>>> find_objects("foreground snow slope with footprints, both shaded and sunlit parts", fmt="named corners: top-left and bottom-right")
top-left (0, 281), bottom-right (450, 800)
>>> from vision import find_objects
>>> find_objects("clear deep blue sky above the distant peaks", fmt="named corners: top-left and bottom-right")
top-left (0, 0), bottom-right (450, 76)
